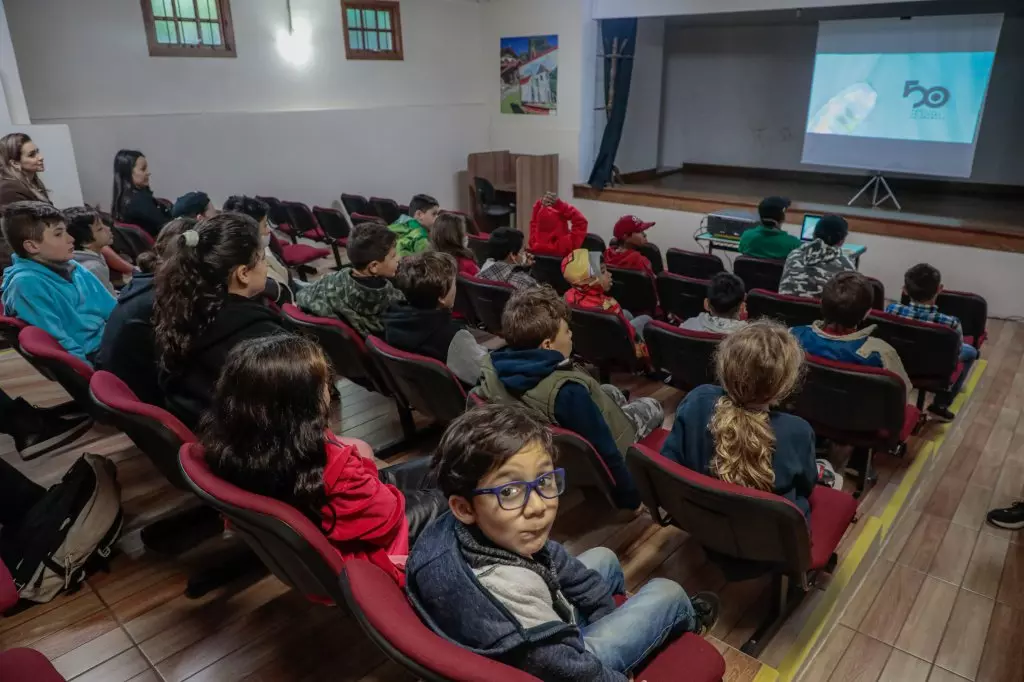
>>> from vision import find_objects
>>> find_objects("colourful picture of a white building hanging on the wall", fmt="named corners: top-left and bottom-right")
top-left (501, 36), bottom-right (558, 116)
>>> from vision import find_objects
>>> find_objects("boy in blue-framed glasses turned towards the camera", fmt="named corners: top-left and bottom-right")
top-left (406, 404), bottom-right (718, 682)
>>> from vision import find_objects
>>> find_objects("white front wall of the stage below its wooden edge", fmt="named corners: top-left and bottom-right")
top-left (575, 193), bottom-right (1024, 316)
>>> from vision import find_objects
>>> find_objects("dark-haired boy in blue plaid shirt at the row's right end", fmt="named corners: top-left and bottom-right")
top-left (886, 263), bottom-right (978, 421)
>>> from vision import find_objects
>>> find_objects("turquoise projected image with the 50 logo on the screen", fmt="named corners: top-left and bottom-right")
top-left (807, 52), bottom-right (995, 143)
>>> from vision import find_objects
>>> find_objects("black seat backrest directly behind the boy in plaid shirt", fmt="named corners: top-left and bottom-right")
top-left (867, 310), bottom-right (961, 390)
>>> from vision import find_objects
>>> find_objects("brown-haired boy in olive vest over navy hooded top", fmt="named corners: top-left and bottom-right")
top-left (473, 287), bottom-right (665, 509)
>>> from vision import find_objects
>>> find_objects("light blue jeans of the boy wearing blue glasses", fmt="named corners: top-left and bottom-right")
top-left (577, 547), bottom-right (697, 674)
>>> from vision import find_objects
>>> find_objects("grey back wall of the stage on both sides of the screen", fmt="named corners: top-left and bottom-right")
top-left (660, 16), bottom-right (1024, 184)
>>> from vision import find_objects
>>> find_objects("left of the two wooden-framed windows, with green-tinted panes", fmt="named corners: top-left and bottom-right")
top-left (141, 0), bottom-right (236, 57)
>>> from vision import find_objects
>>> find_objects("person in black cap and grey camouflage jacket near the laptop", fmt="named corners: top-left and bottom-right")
top-left (778, 215), bottom-right (857, 298)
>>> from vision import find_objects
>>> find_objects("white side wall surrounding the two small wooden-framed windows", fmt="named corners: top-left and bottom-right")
top-left (8, 0), bottom-right (487, 206)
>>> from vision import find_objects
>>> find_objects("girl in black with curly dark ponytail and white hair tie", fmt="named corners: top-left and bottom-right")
top-left (153, 213), bottom-right (285, 427)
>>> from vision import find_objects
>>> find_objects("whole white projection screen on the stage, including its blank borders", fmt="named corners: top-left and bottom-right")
top-left (802, 14), bottom-right (1002, 177)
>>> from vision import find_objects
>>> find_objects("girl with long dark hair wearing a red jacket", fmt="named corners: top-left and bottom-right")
top-left (200, 334), bottom-right (447, 584)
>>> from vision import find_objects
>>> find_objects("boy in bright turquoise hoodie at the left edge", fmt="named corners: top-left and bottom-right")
top-left (2, 202), bottom-right (117, 363)
